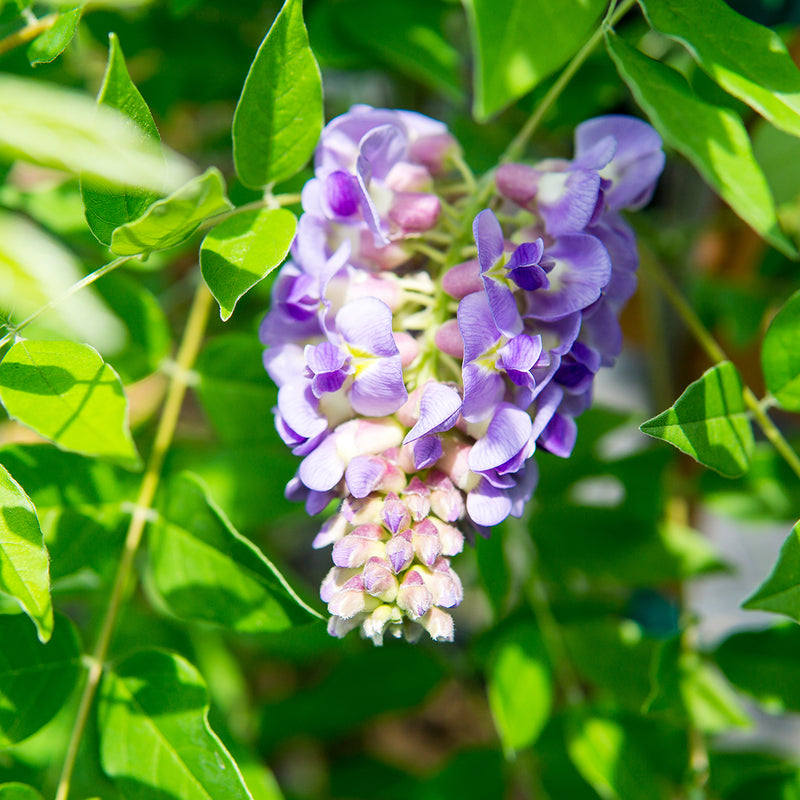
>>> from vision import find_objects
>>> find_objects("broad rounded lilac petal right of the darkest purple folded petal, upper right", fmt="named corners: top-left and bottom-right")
top-left (526, 233), bottom-right (611, 320)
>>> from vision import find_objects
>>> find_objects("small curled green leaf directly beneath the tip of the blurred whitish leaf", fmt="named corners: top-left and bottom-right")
top-left (111, 167), bottom-right (233, 256)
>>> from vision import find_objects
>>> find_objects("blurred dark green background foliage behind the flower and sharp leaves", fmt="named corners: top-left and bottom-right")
top-left (0, 0), bottom-right (800, 800)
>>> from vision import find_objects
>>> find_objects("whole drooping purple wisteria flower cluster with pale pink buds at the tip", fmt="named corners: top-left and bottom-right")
top-left (261, 106), bottom-right (664, 644)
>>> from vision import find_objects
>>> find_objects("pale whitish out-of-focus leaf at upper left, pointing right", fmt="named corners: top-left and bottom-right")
top-left (0, 75), bottom-right (195, 193)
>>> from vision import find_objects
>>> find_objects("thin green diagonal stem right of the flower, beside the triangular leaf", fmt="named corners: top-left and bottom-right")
top-left (642, 250), bottom-right (800, 478)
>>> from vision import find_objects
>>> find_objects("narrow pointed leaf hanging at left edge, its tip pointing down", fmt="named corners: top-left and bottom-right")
top-left (0, 466), bottom-right (53, 642)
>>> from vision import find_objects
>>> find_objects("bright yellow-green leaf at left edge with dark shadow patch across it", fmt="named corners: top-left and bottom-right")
top-left (0, 341), bottom-right (139, 466)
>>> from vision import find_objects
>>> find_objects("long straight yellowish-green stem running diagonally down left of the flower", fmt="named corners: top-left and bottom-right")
top-left (55, 283), bottom-right (213, 800)
